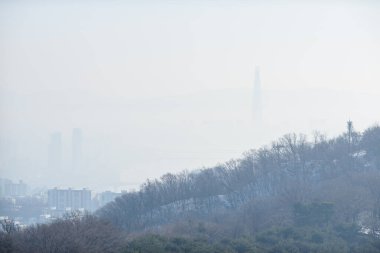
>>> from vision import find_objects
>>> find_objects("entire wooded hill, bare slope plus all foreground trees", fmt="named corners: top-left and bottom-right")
top-left (0, 125), bottom-right (380, 253)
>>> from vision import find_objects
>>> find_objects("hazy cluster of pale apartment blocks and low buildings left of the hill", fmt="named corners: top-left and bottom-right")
top-left (0, 179), bottom-right (122, 225)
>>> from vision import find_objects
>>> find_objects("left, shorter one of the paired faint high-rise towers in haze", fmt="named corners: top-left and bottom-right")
top-left (48, 132), bottom-right (62, 172)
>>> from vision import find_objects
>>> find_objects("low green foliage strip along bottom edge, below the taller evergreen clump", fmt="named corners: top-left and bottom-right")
top-left (123, 226), bottom-right (380, 253)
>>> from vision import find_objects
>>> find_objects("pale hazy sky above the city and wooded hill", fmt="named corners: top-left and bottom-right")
top-left (0, 0), bottom-right (380, 189)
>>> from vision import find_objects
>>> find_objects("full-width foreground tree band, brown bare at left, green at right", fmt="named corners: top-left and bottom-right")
top-left (0, 208), bottom-right (380, 253)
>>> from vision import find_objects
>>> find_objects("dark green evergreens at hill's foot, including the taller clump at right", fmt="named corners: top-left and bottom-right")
top-left (123, 202), bottom-right (380, 253)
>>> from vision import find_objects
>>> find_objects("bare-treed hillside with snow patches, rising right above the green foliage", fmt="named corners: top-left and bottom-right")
top-left (97, 126), bottom-right (380, 235)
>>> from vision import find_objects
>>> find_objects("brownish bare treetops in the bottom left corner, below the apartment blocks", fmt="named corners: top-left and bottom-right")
top-left (0, 212), bottom-right (126, 253)
